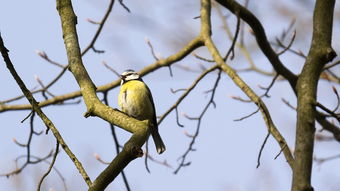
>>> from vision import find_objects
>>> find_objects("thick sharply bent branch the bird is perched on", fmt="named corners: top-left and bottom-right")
top-left (57, 0), bottom-right (153, 190)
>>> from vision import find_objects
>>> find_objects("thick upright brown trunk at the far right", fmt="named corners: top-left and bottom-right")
top-left (292, 0), bottom-right (336, 191)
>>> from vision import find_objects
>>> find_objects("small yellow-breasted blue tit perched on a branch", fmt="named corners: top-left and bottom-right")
top-left (118, 70), bottom-right (165, 154)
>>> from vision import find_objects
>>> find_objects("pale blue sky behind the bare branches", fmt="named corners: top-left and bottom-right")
top-left (0, 0), bottom-right (340, 191)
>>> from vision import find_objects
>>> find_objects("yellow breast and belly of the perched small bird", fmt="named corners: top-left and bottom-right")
top-left (118, 80), bottom-right (155, 120)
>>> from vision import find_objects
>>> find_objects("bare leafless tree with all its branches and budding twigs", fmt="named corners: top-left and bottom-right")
top-left (0, 0), bottom-right (340, 191)
